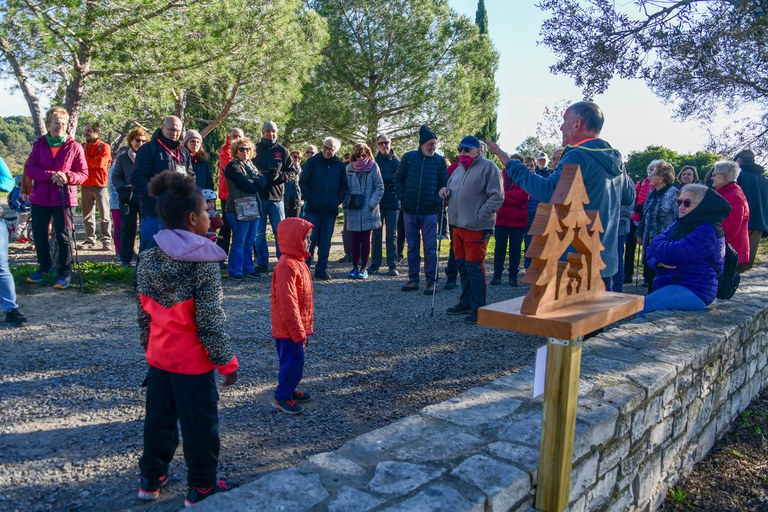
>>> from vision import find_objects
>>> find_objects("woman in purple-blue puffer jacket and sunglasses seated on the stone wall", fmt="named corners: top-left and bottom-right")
top-left (639, 185), bottom-right (731, 316)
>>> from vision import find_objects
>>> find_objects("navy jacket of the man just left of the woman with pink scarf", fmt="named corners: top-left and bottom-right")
top-left (299, 153), bottom-right (348, 217)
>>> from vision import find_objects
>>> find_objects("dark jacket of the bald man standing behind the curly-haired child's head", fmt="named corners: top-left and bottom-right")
top-left (131, 128), bottom-right (194, 217)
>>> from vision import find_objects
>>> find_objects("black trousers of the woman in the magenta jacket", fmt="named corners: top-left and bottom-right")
top-left (31, 204), bottom-right (74, 276)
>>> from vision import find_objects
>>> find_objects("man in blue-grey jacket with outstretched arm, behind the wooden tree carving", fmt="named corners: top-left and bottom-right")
top-left (488, 101), bottom-right (635, 284)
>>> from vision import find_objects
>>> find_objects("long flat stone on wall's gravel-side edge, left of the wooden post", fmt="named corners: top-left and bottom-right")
top-left (421, 388), bottom-right (521, 427)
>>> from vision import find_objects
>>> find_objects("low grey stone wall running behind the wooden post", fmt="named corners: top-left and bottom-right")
top-left (196, 268), bottom-right (768, 512)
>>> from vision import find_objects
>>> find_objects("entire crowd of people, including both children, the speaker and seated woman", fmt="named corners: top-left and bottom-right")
top-left (0, 101), bottom-right (768, 505)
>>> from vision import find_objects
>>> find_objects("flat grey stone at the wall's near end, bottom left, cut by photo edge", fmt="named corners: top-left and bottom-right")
top-left (195, 468), bottom-right (329, 512)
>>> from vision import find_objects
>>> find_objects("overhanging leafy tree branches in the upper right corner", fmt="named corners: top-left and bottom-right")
top-left (538, 0), bottom-right (768, 154)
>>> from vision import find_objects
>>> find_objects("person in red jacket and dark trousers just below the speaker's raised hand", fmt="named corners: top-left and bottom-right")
top-left (491, 173), bottom-right (529, 286)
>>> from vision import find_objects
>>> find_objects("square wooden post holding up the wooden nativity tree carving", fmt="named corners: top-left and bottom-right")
top-left (536, 337), bottom-right (582, 512)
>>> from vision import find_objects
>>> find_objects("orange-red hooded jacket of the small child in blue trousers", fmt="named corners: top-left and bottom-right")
top-left (272, 217), bottom-right (315, 343)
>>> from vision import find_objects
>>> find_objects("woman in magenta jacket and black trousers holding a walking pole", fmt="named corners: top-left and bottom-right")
top-left (24, 107), bottom-right (88, 290)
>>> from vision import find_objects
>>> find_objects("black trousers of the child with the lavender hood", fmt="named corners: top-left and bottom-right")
top-left (139, 367), bottom-right (219, 488)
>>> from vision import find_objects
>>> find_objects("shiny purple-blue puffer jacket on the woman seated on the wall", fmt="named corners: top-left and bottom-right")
top-left (648, 223), bottom-right (725, 306)
